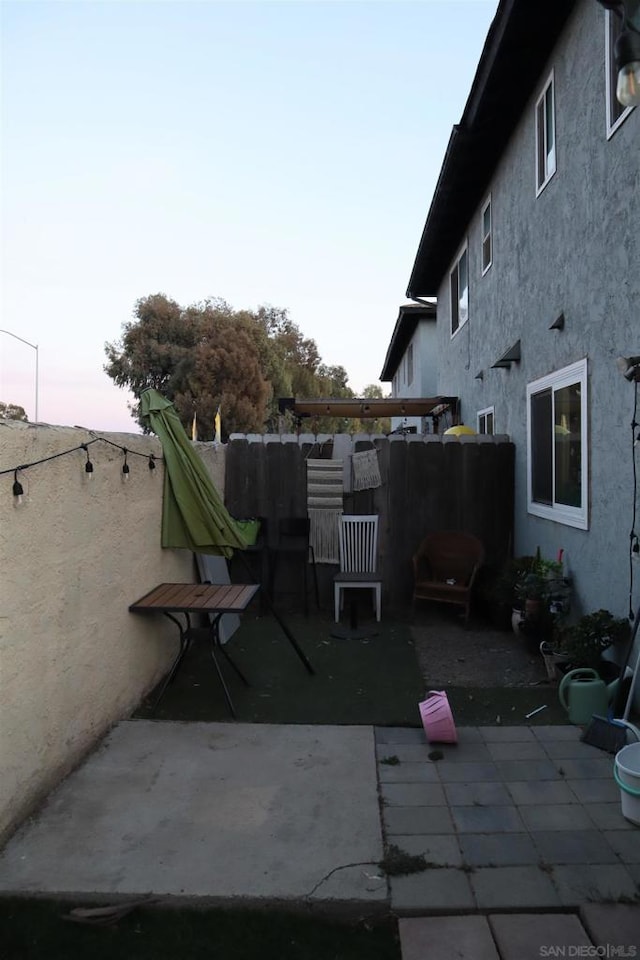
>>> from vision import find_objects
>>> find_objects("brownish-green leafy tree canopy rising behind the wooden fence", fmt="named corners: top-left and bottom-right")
top-left (104, 293), bottom-right (379, 438)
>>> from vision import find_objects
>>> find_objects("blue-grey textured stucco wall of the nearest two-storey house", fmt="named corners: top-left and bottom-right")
top-left (437, 2), bottom-right (640, 615)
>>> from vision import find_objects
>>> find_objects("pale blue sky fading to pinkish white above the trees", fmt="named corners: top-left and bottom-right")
top-left (0, 0), bottom-right (498, 431)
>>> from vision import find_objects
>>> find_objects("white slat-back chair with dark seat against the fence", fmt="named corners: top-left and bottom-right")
top-left (333, 514), bottom-right (382, 623)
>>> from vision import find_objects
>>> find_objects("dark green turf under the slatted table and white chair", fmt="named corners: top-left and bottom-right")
top-left (135, 615), bottom-right (424, 726)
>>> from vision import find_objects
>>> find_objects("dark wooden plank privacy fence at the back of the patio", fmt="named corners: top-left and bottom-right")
top-left (225, 435), bottom-right (514, 608)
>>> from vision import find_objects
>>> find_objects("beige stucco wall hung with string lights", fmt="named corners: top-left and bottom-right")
top-left (0, 421), bottom-right (229, 841)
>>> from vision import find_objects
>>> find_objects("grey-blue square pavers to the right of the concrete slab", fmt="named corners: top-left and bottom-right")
top-left (376, 726), bottom-right (640, 912)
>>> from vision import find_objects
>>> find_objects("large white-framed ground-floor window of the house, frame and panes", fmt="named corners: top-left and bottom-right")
top-left (527, 359), bottom-right (589, 530)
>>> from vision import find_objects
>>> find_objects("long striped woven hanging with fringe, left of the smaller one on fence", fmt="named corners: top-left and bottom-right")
top-left (307, 460), bottom-right (343, 563)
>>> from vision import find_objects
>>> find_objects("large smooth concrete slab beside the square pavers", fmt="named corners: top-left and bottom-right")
top-left (0, 720), bottom-right (387, 904)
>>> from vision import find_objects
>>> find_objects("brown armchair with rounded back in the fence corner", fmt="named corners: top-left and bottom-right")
top-left (413, 530), bottom-right (484, 623)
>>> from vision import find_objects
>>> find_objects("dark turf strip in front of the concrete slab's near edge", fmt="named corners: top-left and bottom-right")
top-left (0, 897), bottom-right (400, 960)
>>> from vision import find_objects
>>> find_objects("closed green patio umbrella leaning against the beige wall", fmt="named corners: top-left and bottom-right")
top-left (140, 389), bottom-right (247, 557)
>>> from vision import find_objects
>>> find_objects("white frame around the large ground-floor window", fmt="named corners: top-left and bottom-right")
top-left (527, 357), bottom-right (589, 530)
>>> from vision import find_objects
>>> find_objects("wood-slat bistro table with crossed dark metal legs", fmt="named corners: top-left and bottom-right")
top-left (129, 583), bottom-right (260, 717)
